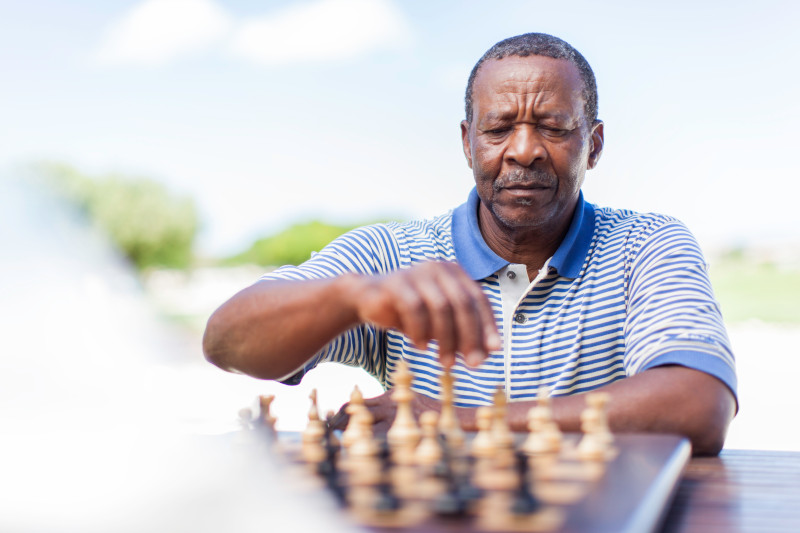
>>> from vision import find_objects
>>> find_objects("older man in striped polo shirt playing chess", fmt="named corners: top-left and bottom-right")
top-left (203, 33), bottom-right (736, 454)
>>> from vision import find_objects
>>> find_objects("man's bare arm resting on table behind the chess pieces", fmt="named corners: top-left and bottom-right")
top-left (346, 365), bottom-right (736, 455)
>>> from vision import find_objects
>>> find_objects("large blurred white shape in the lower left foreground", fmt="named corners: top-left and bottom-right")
top-left (0, 178), bottom-right (358, 532)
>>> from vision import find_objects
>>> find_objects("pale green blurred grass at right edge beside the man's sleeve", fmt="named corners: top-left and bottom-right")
top-left (709, 254), bottom-right (800, 324)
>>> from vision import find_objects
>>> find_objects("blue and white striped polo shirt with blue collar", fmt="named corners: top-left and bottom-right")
top-left (261, 189), bottom-right (736, 407)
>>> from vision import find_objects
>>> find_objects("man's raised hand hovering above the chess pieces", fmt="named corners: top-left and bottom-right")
top-left (355, 262), bottom-right (501, 368)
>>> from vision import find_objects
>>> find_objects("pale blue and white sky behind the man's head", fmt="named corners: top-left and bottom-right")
top-left (0, 0), bottom-right (800, 254)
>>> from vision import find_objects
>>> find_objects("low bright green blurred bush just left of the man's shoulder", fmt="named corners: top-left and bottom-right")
top-left (226, 220), bottom-right (355, 266)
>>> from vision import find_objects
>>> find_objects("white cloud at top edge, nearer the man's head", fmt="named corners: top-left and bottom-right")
top-left (230, 0), bottom-right (410, 65)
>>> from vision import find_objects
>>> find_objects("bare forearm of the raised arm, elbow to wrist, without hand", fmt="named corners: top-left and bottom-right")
top-left (203, 275), bottom-right (358, 379)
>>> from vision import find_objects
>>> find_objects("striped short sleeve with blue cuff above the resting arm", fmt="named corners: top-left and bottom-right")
top-left (624, 217), bottom-right (737, 396)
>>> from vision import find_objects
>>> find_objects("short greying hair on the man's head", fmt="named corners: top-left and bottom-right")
top-left (464, 33), bottom-right (597, 124)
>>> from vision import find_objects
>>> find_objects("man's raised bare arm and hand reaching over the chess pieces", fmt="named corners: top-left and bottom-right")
top-left (203, 262), bottom-right (500, 379)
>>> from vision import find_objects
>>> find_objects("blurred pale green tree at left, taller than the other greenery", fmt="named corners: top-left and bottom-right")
top-left (38, 164), bottom-right (198, 270)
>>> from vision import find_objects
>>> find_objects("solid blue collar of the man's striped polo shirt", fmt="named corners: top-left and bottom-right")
top-left (452, 188), bottom-right (594, 280)
